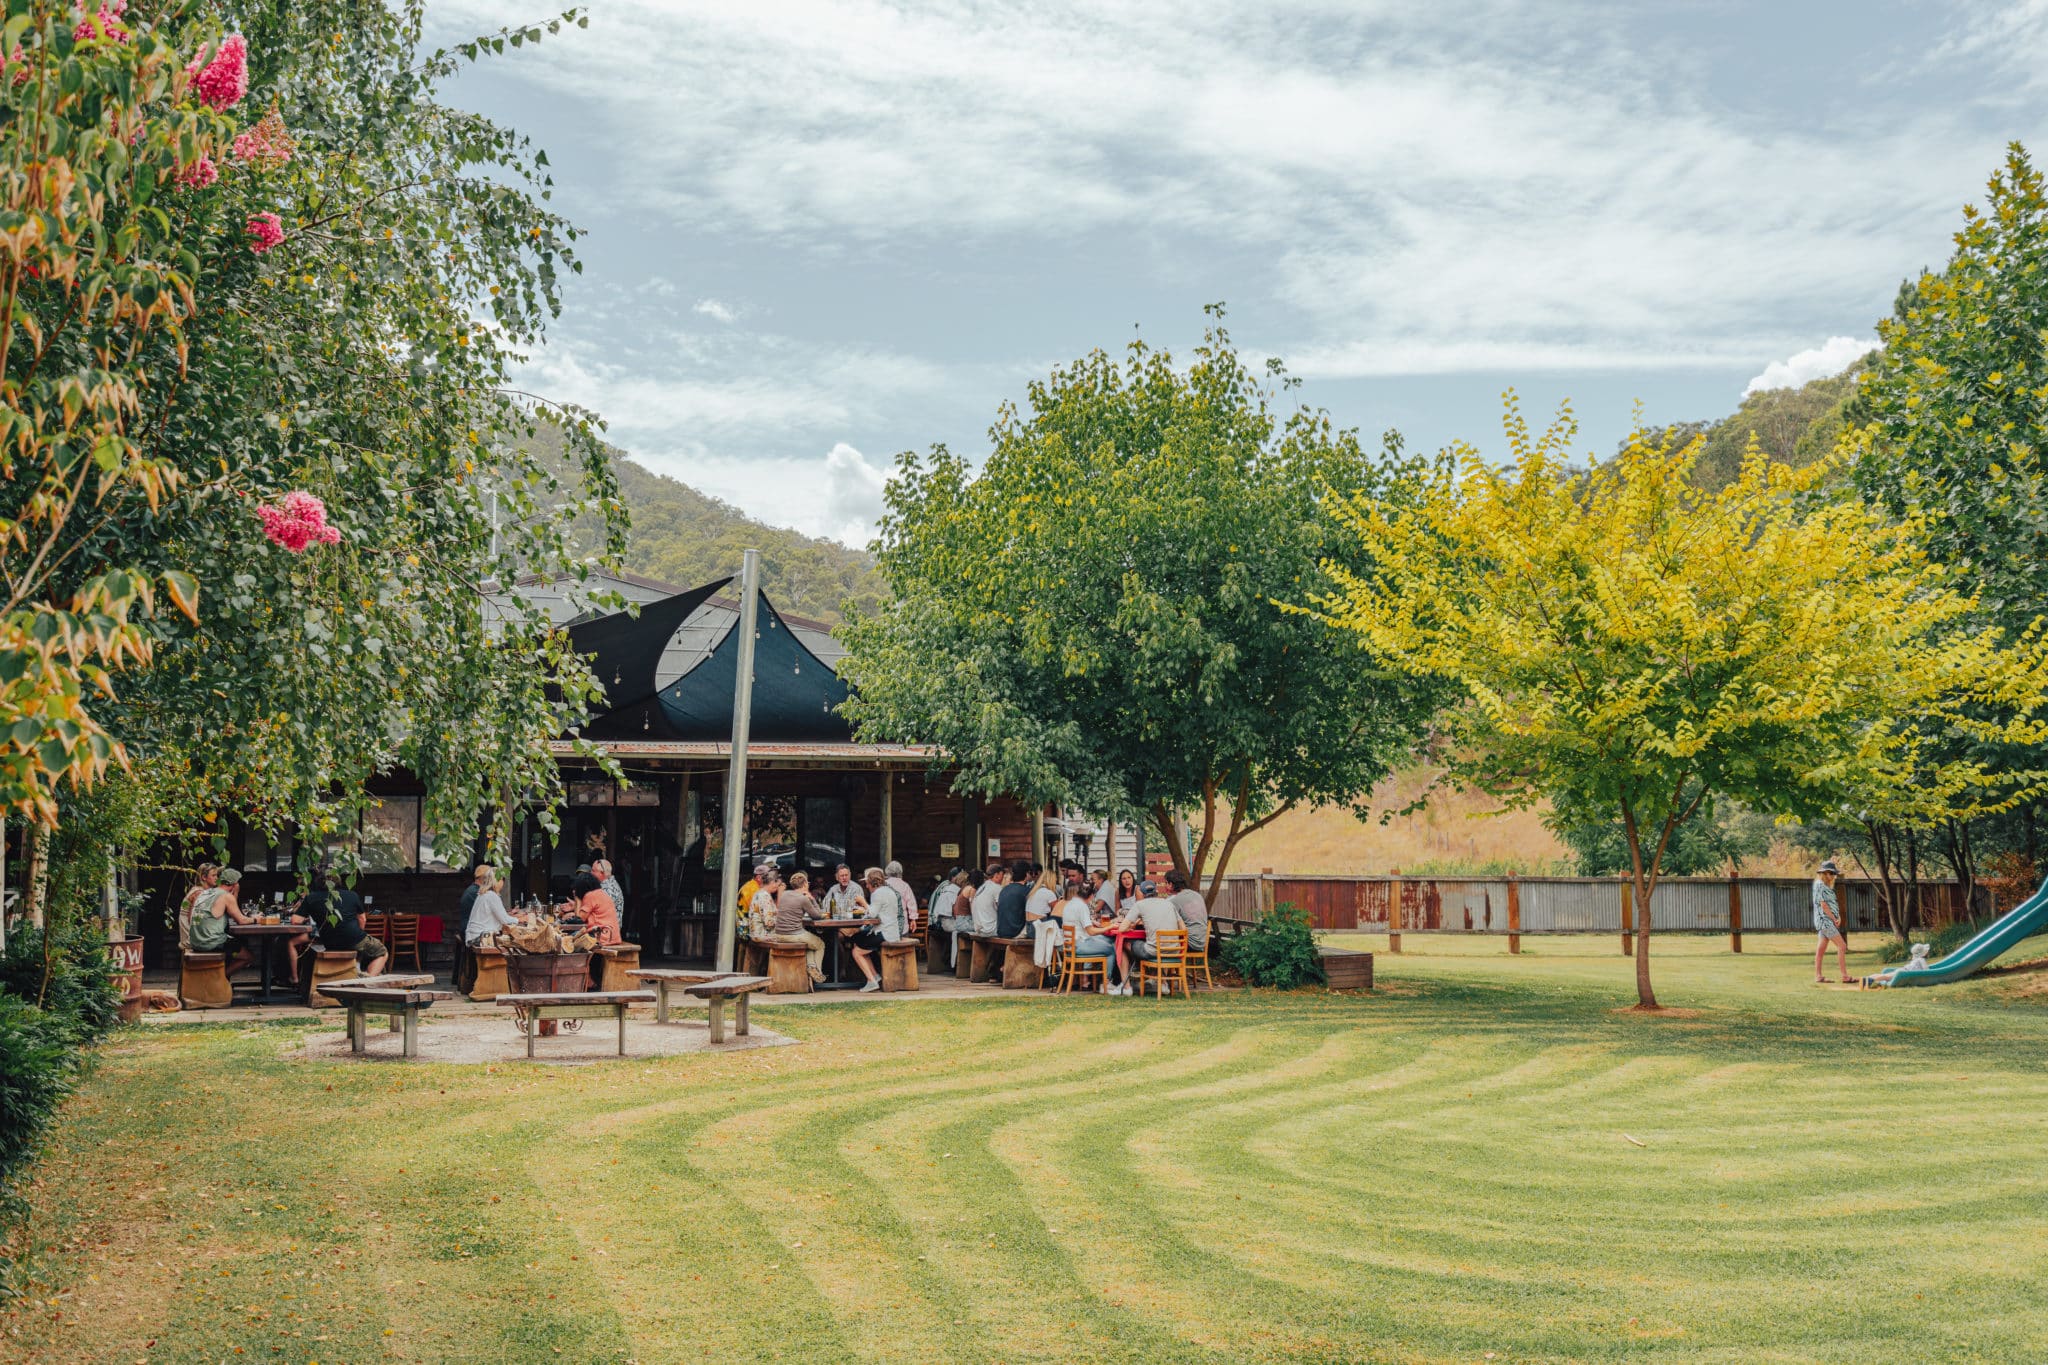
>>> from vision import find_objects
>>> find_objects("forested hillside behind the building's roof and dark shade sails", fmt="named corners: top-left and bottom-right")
top-left (537, 428), bottom-right (883, 622)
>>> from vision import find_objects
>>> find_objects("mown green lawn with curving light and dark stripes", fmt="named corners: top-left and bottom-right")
top-left (0, 937), bottom-right (2048, 1365)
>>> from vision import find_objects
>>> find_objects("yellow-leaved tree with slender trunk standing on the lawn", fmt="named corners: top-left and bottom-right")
top-left (1317, 397), bottom-right (2042, 1009)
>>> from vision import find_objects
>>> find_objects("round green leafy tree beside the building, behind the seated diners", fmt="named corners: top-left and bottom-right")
top-left (842, 307), bottom-right (1446, 892)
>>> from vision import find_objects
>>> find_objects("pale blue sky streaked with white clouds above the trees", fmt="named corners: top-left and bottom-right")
top-left (428, 0), bottom-right (2048, 544)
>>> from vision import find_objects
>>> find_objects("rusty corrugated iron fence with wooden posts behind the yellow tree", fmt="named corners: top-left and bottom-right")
top-left (1210, 872), bottom-right (1991, 933)
